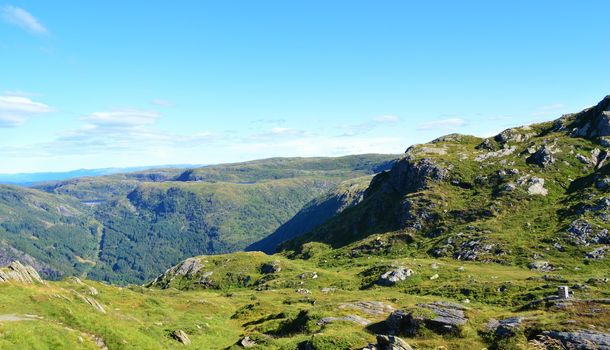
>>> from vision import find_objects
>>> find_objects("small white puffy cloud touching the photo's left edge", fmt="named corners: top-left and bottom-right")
top-left (0, 96), bottom-right (52, 128)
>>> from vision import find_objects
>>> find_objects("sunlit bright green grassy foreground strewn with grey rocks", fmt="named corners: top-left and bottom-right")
top-left (0, 253), bottom-right (610, 350)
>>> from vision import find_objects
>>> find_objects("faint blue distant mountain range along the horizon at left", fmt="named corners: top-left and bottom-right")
top-left (0, 164), bottom-right (202, 186)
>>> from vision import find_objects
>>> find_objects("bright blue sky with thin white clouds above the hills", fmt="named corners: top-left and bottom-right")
top-left (0, 0), bottom-right (610, 173)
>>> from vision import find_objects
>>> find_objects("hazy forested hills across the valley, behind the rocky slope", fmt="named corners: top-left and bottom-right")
top-left (0, 155), bottom-right (395, 283)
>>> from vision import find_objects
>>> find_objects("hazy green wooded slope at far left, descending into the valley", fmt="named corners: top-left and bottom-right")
top-left (0, 185), bottom-right (102, 278)
